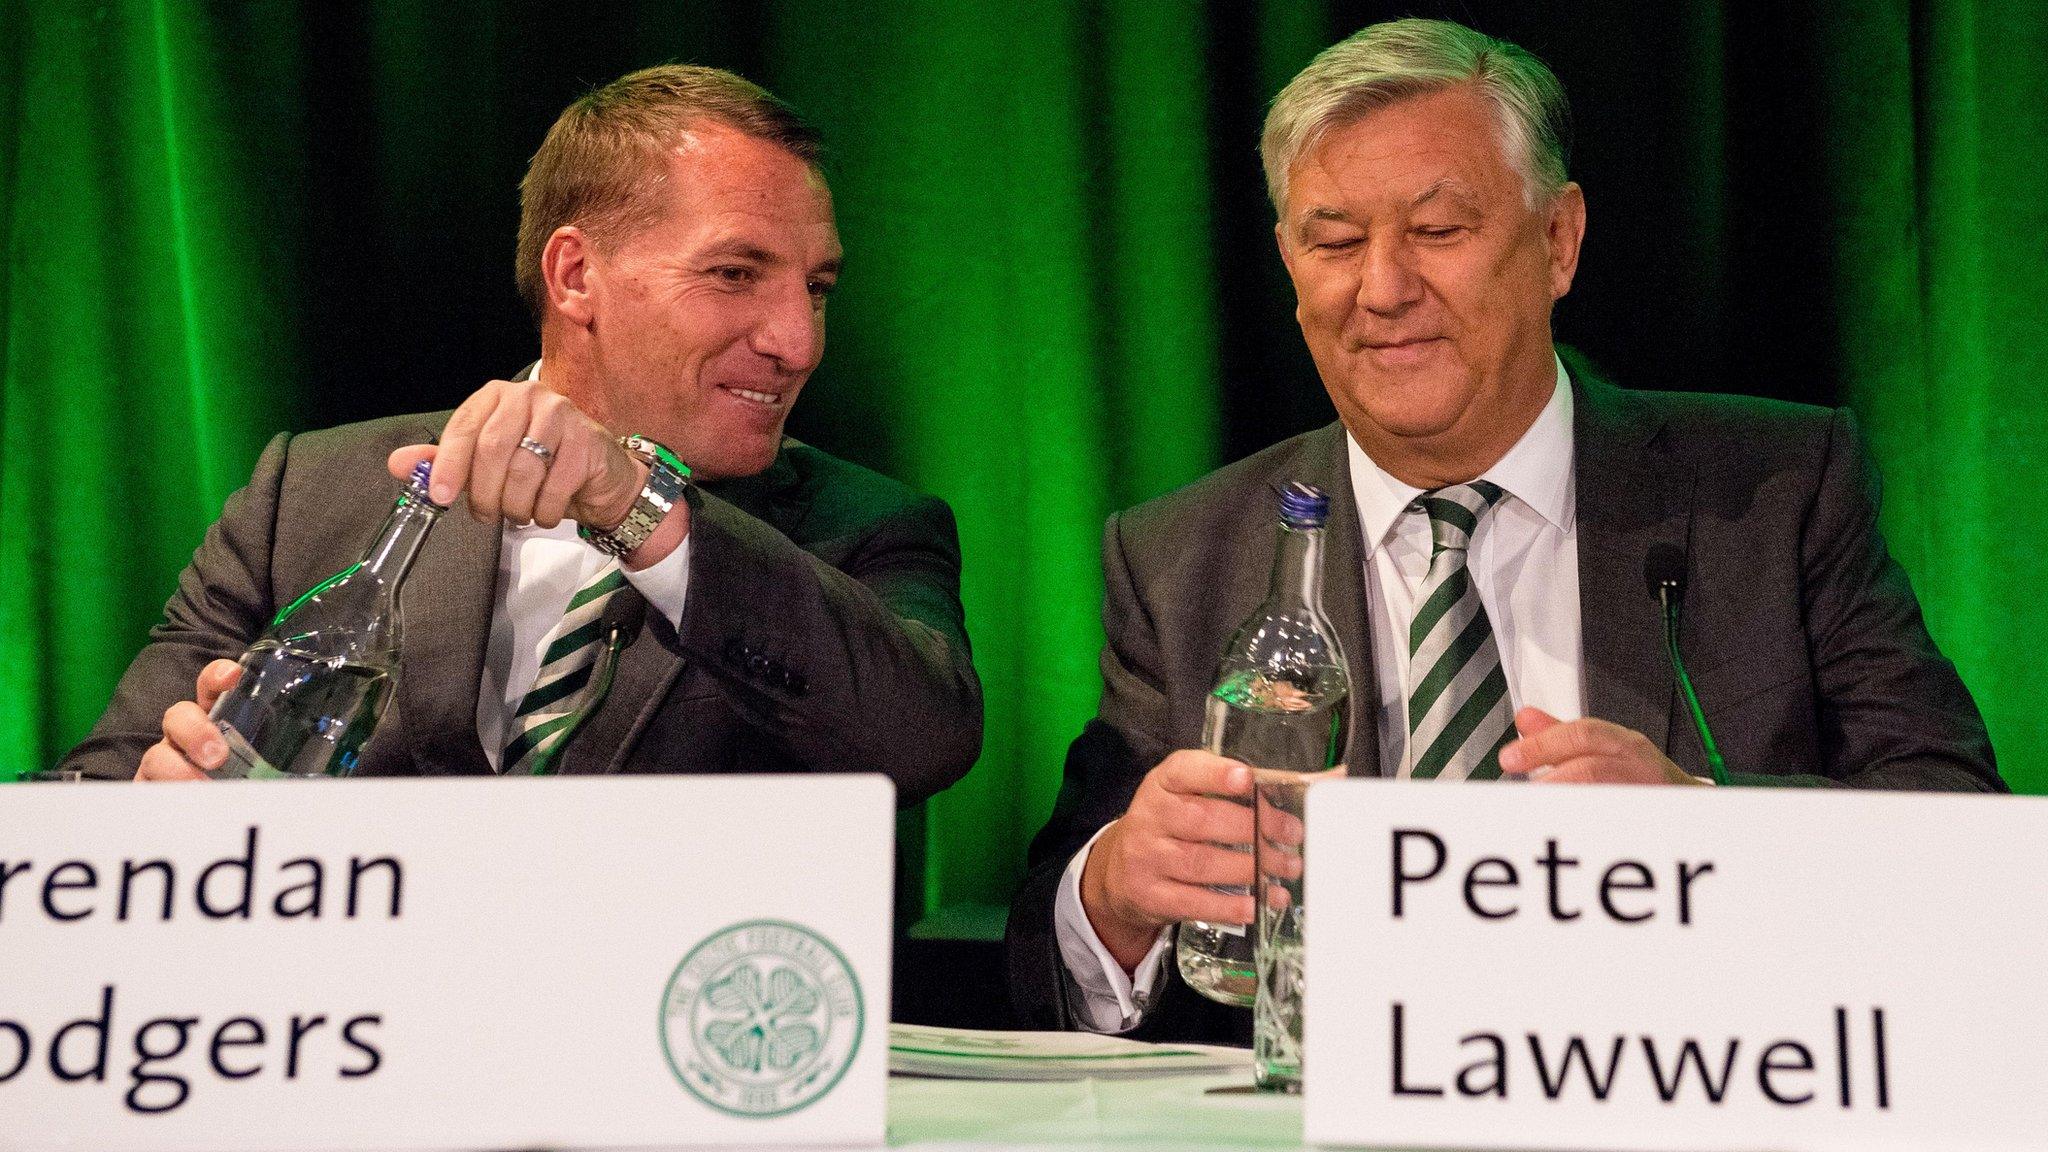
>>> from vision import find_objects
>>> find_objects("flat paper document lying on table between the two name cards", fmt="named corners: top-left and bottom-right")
top-left (889, 1025), bottom-right (1251, 1080)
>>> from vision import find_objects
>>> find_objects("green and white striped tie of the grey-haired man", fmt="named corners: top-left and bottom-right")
top-left (1409, 480), bottom-right (1516, 781)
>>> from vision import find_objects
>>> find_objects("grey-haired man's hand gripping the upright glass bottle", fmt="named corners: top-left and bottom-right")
top-left (1081, 748), bottom-right (1251, 972)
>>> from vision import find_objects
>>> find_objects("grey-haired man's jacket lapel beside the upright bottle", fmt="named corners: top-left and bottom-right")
top-left (1276, 424), bottom-right (1380, 777)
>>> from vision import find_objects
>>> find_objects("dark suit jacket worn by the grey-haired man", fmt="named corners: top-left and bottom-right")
top-left (1006, 353), bottom-right (2003, 1043)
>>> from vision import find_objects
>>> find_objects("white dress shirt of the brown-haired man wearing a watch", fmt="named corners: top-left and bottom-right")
top-left (477, 365), bottom-right (690, 773)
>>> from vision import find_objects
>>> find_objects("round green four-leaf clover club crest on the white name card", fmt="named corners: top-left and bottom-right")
top-left (662, 920), bottom-right (862, 1117)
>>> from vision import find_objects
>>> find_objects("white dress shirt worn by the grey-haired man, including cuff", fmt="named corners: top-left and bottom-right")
top-left (1053, 361), bottom-right (1585, 1033)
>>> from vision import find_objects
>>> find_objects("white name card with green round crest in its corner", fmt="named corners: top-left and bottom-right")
top-left (0, 775), bottom-right (895, 1152)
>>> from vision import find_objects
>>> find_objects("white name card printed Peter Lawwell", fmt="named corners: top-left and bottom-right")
top-left (1303, 781), bottom-right (2048, 1150)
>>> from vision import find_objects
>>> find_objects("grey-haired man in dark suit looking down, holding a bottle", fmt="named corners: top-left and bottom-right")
top-left (1008, 20), bottom-right (2003, 1041)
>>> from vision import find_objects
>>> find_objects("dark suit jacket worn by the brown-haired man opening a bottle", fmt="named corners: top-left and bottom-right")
top-left (66, 412), bottom-right (981, 806)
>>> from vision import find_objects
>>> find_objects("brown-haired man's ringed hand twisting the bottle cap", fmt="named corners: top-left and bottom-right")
top-left (389, 379), bottom-right (647, 531)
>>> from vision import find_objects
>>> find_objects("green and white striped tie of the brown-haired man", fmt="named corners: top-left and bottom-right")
top-left (500, 562), bottom-right (627, 777)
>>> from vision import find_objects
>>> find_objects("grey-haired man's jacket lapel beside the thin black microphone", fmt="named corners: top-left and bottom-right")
top-left (1569, 361), bottom-right (1694, 750)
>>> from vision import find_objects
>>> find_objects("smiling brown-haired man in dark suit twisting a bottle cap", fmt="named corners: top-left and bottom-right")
top-left (66, 66), bottom-right (981, 806)
